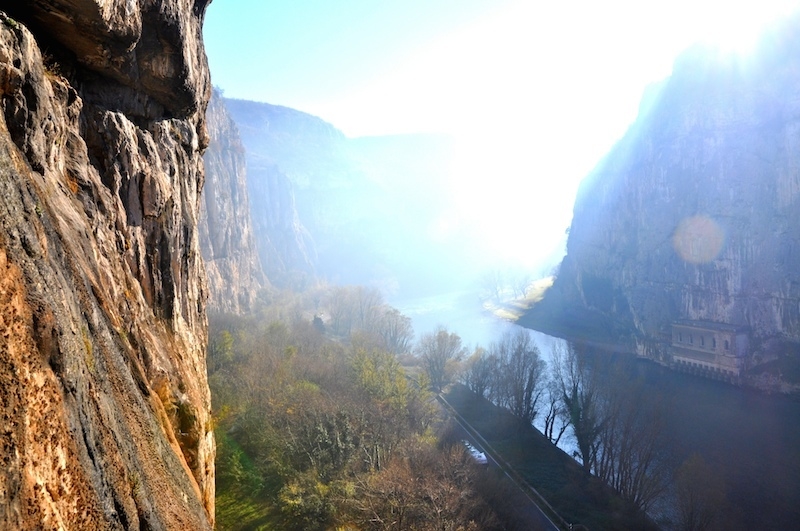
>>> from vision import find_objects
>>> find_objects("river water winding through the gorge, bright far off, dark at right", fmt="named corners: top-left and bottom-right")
top-left (393, 291), bottom-right (800, 529)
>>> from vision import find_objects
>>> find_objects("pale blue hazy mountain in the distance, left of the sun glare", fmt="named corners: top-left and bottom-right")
top-left (226, 100), bottom-right (474, 294)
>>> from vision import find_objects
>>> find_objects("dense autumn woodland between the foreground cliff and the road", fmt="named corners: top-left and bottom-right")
top-left (208, 288), bottom-right (505, 529)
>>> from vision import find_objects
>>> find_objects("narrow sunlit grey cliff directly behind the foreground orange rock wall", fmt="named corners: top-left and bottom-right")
top-left (199, 92), bottom-right (271, 313)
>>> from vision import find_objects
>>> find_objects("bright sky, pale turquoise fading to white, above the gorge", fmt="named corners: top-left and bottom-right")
top-left (204, 0), bottom-right (798, 267)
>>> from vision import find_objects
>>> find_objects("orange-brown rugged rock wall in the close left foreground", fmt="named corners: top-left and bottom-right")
top-left (0, 0), bottom-right (214, 529)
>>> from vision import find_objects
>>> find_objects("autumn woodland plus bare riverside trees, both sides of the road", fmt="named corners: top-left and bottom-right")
top-left (208, 284), bottom-right (725, 530)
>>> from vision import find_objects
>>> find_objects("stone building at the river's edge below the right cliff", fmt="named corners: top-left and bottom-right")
top-left (670, 320), bottom-right (750, 380)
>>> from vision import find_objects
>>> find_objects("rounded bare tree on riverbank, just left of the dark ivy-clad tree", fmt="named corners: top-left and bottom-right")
top-left (490, 328), bottom-right (546, 426)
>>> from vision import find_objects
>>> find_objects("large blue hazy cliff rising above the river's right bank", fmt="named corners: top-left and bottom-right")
top-left (520, 15), bottom-right (800, 378)
